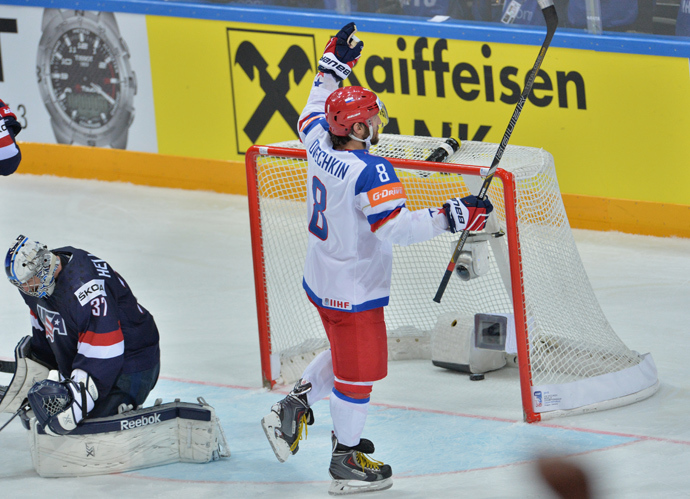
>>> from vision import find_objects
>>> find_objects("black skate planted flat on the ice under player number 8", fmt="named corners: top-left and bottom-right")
top-left (328, 434), bottom-right (393, 496)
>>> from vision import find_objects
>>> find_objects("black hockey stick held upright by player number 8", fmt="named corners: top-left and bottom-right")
top-left (434, 0), bottom-right (558, 303)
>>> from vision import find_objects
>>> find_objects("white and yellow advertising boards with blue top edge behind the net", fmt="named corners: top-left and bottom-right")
top-left (0, 2), bottom-right (690, 205)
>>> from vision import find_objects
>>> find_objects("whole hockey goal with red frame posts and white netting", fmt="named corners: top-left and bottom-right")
top-left (246, 134), bottom-right (659, 422)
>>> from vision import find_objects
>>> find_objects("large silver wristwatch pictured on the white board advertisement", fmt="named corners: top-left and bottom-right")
top-left (36, 9), bottom-right (137, 149)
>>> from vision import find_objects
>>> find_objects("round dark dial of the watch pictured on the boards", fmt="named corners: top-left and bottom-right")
top-left (48, 28), bottom-right (122, 128)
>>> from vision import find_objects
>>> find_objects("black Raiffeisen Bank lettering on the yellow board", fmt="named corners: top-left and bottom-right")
top-left (348, 35), bottom-right (584, 142)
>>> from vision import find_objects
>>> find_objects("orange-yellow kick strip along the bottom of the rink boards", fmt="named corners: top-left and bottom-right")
top-left (18, 142), bottom-right (690, 238)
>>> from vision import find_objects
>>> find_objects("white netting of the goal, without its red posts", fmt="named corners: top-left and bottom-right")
top-left (251, 134), bottom-right (641, 392)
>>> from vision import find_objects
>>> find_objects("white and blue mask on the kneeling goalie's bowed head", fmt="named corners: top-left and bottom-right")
top-left (5, 236), bottom-right (58, 298)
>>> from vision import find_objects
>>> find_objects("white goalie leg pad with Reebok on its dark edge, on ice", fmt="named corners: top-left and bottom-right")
top-left (29, 397), bottom-right (230, 477)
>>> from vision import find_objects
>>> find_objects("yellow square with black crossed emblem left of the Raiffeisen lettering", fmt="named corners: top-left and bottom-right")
top-left (227, 28), bottom-right (317, 154)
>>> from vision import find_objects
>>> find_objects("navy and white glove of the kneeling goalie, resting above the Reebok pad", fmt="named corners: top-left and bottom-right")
top-left (27, 369), bottom-right (98, 436)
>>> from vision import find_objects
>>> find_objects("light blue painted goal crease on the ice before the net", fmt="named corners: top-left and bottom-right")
top-left (133, 379), bottom-right (637, 483)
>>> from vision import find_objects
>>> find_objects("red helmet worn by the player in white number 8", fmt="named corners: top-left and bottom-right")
top-left (326, 87), bottom-right (388, 137)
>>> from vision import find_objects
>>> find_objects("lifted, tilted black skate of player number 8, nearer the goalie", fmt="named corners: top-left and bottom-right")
top-left (261, 379), bottom-right (314, 463)
